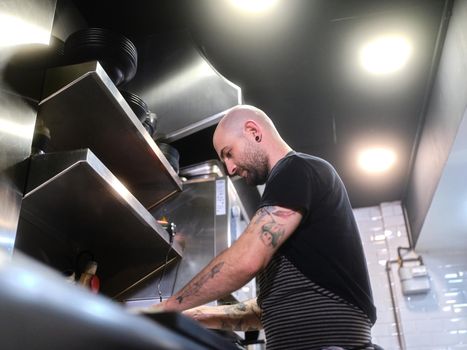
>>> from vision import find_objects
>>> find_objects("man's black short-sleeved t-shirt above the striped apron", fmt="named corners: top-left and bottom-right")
top-left (259, 152), bottom-right (376, 323)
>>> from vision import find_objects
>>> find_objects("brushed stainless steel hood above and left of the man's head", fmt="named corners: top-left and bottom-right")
top-left (123, 32), bottom-right (242, 142)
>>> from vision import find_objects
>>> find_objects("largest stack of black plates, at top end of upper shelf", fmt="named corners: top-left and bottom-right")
top-left (64, 28), bottom-right (138, 86)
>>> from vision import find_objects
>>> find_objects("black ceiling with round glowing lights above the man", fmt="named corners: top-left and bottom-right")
top-left (74, 0), bottom-right (446, 207)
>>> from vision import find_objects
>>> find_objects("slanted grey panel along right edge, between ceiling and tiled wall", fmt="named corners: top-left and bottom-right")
top-left (402, 1), bottom-right (460, 249)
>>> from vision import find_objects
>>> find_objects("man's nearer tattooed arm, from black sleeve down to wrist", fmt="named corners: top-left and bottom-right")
top-left (148, 206), bottom-right (302, 311)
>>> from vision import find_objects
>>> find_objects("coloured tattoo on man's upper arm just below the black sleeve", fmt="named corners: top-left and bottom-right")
top-left (255, 207), bottom-right (295, 248)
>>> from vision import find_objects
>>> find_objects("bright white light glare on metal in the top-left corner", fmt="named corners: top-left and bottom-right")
top-left (0, 13), bottom-right (50, 47)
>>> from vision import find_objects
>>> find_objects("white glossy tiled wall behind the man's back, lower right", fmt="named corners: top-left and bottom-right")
top-left (354, 202), bottom-right (467, 350)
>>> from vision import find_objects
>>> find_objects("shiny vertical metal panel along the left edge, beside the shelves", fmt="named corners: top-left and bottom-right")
top-left (0, 0), bottom-right (56, 254)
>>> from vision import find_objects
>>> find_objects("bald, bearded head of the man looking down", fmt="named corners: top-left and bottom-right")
top-left (213, 105), bottom-right (290, 185)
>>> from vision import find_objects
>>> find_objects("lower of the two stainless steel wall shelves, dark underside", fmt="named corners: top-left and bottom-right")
top-left (17, 149), bottom-right (182, 297)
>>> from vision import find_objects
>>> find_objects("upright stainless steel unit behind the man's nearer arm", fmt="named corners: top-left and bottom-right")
top-left (119, 161), bottom-right (257, 306)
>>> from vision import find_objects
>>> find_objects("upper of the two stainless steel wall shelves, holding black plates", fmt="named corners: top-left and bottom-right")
top-left (38, 61), bottom-right (182, 208)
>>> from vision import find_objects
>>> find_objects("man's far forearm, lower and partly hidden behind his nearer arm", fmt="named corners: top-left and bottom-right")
top-left (183, 299), bottom-right (262, 331)
